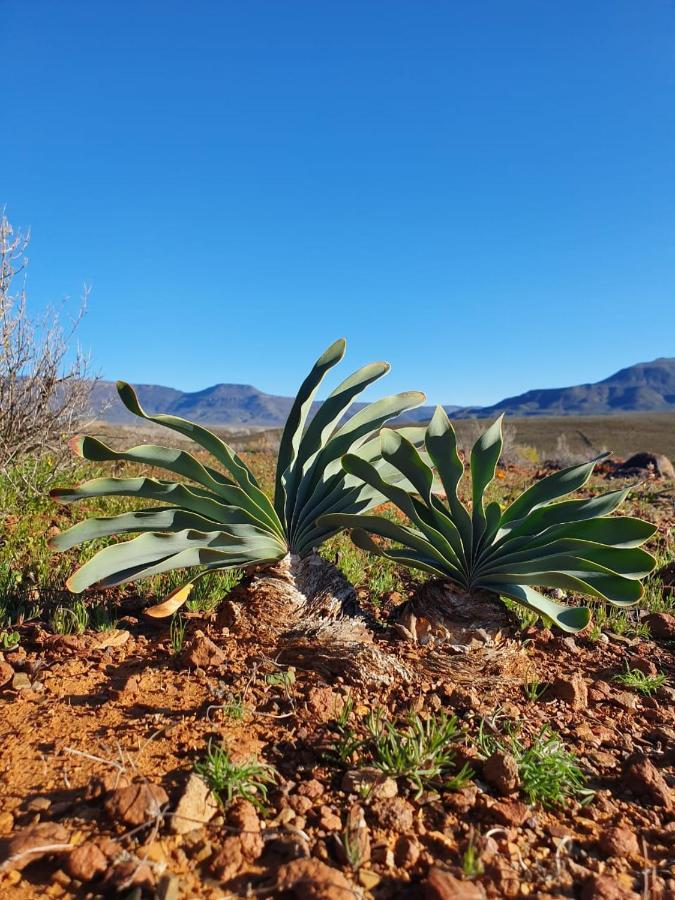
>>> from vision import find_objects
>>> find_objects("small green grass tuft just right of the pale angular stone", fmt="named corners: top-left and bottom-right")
top-left (195, 741), bottom-right (278, 809)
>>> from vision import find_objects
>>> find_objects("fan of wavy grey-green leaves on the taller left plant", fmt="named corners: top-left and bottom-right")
top-left (50, 339), bottom-right (424, 616)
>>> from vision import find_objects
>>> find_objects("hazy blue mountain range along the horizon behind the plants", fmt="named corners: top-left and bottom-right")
top-left (92, 357), bottom-right (675, 428)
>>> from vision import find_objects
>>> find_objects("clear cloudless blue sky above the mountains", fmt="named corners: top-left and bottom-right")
top-left (0, 0), bottom-right (675, 404)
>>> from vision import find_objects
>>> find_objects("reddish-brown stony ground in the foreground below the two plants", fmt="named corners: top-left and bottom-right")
top-left (0, 460), bottom-right (675, 900)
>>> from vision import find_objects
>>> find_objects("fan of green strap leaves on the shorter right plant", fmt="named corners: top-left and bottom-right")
top-left (319, 407), bottom-right (656, 632)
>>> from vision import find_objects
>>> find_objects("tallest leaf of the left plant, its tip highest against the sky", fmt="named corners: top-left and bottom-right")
top-left (274, 338), bottom-right (347, 522)
